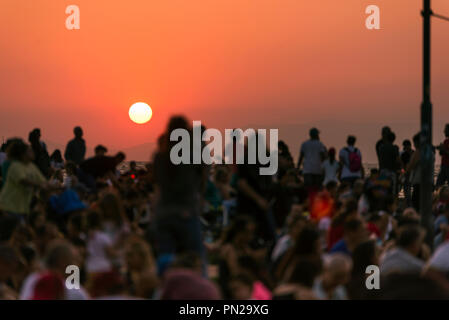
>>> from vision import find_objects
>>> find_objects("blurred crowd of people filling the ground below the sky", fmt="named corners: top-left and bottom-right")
top-left (0, 116), bottom-right (449, 300)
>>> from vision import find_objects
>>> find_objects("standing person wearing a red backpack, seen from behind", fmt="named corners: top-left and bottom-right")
top-left (339, 136), bottom-right (365, 186)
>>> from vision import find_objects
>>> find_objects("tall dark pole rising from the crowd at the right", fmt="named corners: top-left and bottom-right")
top-left (420, 0), bottom-right (434, 247)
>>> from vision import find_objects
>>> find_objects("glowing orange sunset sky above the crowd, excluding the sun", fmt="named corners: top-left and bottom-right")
top-left (0, 0), bottom-right (449, 160)
